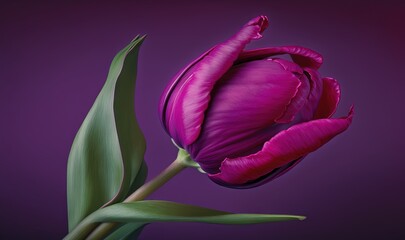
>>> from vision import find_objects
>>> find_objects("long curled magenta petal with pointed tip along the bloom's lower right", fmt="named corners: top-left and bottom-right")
top-left (209, 109), bottom-right (353, 186)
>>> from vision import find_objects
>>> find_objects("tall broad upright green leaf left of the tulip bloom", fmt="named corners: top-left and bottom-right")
top-left (67, 36), bottom-right (146, 231)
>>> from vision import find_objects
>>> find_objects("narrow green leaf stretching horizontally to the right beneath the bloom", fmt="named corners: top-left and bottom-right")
top-left (84, 200), bottom-right (305, 239)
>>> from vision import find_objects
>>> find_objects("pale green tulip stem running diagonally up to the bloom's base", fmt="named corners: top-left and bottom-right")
top-left (64, 149), bottom-right (195, 240)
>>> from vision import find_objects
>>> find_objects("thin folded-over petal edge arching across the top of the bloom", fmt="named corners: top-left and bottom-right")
top-left (238, 46), bottom-right (323, 70)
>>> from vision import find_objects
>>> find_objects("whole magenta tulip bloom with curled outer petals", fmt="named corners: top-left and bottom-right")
top-left (159, 16), bottom-right (353, 188)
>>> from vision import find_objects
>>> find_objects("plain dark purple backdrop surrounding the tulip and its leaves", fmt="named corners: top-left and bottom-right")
top-left (0, 0), bottom-right (405, 239)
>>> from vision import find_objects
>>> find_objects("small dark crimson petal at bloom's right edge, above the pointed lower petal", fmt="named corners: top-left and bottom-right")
top-left (314, 78), bottom-right (340, 119)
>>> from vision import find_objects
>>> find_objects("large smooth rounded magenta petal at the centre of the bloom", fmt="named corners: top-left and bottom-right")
top-left (187, 60), bottom-right (300, 173)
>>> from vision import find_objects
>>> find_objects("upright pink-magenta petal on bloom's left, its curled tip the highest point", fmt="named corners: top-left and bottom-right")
top-left (166, 16), bottom-right (268, 147)
